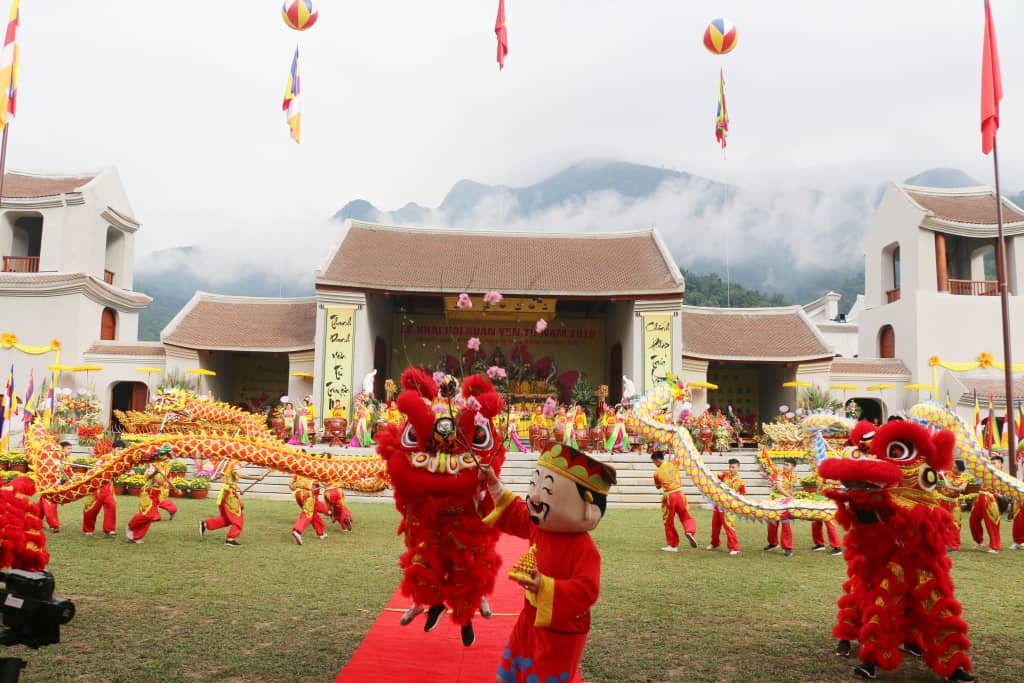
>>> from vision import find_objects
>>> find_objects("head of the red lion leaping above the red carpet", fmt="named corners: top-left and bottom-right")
top-left (377, 368), bottom-right (505, 495)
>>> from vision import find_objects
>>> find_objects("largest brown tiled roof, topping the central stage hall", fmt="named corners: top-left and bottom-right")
top-left (316, 221), bottom-right (683, 296)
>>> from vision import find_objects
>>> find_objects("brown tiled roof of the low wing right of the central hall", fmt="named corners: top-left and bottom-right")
top-left (682, 306), bottom-right (833, 360)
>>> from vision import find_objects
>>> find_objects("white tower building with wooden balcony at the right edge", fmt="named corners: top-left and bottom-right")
top-left (859, 184), bottom-right (1024, 417)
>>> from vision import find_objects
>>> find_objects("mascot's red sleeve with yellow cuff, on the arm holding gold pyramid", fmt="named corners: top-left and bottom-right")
top-left (534, 533), bottom-right (601, 633)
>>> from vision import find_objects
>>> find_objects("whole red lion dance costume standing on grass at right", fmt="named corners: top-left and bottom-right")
top-left (818, 420), bottom-right (977, 682)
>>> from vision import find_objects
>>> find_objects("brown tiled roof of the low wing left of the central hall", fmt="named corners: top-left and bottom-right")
top-left (160, 292), bottom-right (316, 351)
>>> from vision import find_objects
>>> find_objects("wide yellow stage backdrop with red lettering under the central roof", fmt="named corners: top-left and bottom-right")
top-left (391, 315), bottom-right (607, 387)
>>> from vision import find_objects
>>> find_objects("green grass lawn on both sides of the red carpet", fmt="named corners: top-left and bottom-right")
top-left (14, 497), bottom-right (1024, 683)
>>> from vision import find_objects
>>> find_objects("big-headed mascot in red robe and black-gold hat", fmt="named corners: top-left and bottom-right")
top-left (480, 443), bottom-right (615, 683)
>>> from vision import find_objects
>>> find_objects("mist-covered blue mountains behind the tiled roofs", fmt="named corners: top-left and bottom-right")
top-left (135, 161), bottom-right (1024, 339)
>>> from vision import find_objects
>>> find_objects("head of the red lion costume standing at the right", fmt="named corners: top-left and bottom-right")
top-left (818, 420), bottom-right (956, 516)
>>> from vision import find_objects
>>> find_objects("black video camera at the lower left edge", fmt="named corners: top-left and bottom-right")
top-left (0, 569), bottom-right (75, 651)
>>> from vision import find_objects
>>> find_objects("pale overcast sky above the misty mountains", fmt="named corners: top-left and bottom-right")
top-left (9, 0), bottom-right (1024, 255)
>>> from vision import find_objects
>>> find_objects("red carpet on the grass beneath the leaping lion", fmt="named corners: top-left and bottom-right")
top-left (335, 536), bottom-right (582, 683)
